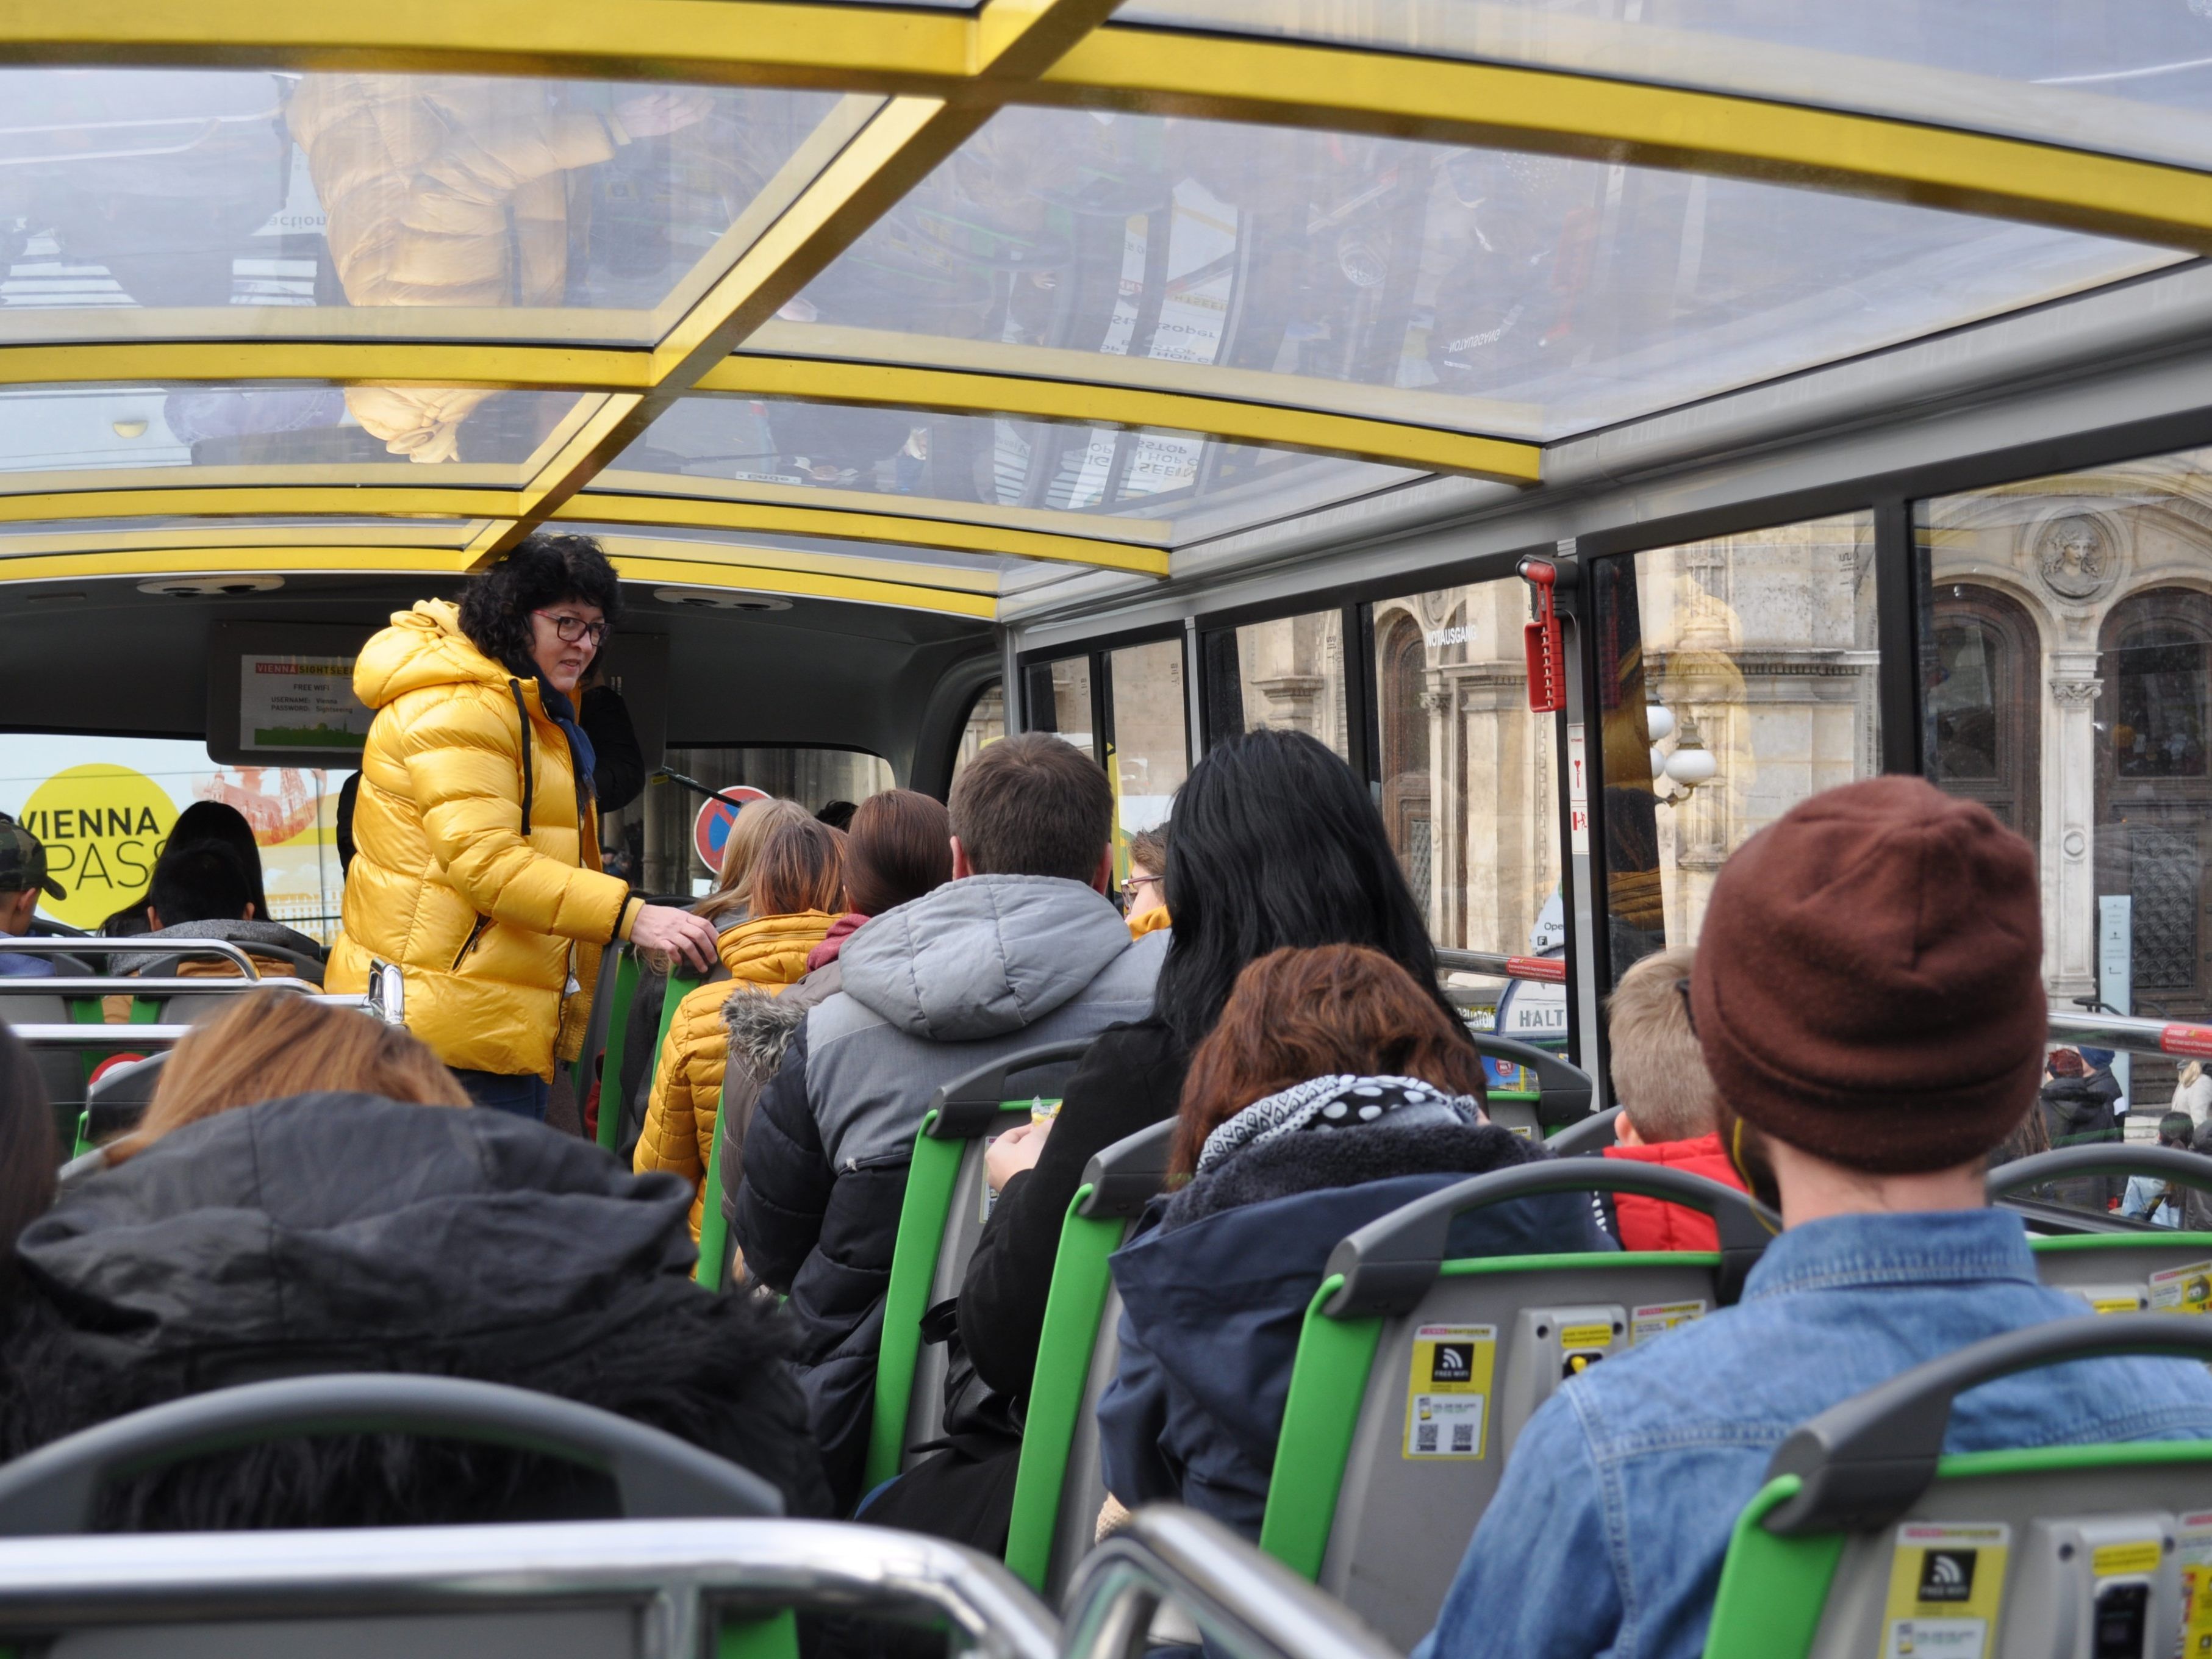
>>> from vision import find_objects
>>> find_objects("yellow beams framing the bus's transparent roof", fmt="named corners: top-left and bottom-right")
top-left (0, 0), bottom-right (2212, 615)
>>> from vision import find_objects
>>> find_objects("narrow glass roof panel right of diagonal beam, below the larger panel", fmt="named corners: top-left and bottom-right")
top-left (600, 396), bottom-right (1420, 544)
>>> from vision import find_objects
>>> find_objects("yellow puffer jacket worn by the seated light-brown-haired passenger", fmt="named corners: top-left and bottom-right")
top-left (631, 909), bottom-right (836, 1239)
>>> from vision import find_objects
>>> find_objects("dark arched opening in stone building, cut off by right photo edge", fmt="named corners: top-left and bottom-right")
top-left (2097, 589), bottom-right (2212, 1017)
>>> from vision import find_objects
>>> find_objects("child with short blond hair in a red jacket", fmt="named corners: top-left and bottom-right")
top-left (1604, 947), bottom-right (1743, 1250)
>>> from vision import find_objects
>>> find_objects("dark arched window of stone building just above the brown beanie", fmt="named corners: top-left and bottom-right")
top-left (1927, 584), bottom-right (2042, 845)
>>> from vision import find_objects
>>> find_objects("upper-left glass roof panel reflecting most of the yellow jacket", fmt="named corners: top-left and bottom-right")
top-left (0, 68), bottom-right (839, 341)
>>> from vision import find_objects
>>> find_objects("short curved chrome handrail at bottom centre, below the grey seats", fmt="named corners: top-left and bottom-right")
top-left (1064, 1504), bottom-right (1398, 1659)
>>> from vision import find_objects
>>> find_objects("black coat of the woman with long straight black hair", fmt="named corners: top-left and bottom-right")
top-left (960, 1020), bottom-right (1190, 1400)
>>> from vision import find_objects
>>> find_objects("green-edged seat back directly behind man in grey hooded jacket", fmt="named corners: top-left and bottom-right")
top-left (863, 1037), bottom-right (1090, 1489)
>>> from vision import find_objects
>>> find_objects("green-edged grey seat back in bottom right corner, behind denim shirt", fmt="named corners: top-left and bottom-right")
top-left (1705, 1314), bottom-right (2212, 1659)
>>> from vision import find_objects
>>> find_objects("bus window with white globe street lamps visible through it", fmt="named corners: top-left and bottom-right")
top-left (1588, 513), bottom-right (1880, 978)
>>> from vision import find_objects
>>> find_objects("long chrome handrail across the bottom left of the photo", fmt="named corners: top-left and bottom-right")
top-left (0, 1520), bottom-right (1053, 1659)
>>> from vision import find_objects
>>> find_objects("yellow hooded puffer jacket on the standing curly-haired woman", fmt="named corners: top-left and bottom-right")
top-left (323, 600), bottom-right (637, 1077)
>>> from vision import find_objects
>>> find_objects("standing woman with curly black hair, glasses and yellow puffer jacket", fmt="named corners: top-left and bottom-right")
top-left (325, 536), bottom-right (715, 1119)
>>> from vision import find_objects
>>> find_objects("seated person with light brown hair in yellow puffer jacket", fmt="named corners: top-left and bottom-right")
top-left (635, 814), bottom-right (845, 1239)
